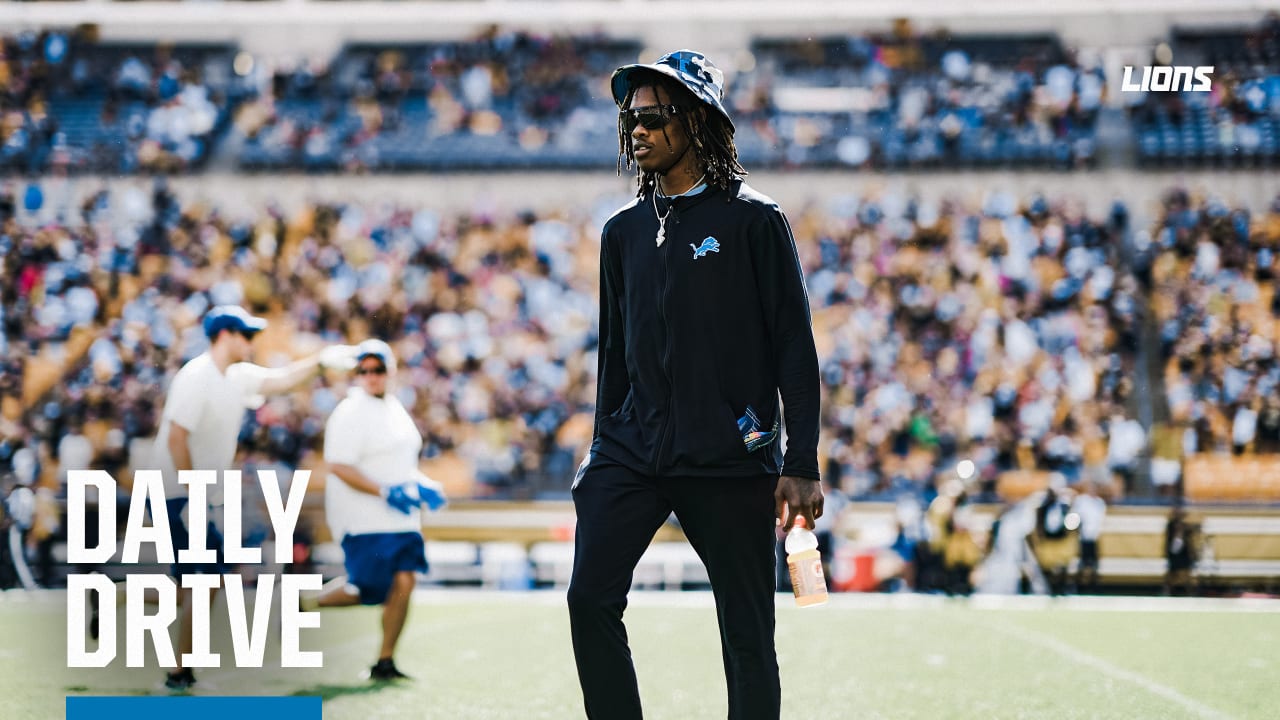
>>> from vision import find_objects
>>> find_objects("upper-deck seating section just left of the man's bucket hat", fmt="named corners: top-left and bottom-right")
top-left (239, 33), bottom-right (640, 170)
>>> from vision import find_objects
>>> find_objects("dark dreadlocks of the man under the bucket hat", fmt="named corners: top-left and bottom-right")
top-left (618, 73), bottom-right (746, 195)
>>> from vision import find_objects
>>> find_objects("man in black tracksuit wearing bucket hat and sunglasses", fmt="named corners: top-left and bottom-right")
top-left (568, 50), bottom-right (822, 720)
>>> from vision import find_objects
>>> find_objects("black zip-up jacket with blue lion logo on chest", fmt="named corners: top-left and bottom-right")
top-left (579, 181), bottom-right (819, 479)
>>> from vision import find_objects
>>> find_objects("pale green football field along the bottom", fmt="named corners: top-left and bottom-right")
top-left (0, 591), bottom-right (1280, 720)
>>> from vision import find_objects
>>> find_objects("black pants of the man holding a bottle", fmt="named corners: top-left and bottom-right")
top-left (568, 465), bottom-right (781, 720)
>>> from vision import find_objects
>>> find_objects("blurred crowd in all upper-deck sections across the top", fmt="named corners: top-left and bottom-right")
top-left (0, 15), bottom-right (1280, 173)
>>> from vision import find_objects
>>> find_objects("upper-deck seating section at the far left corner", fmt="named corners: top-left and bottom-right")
top-left (0, 28), bottom-right (243, 173)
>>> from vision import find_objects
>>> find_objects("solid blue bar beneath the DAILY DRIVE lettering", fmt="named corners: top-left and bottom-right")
top-left (67, 697), bottom-right (321, 720)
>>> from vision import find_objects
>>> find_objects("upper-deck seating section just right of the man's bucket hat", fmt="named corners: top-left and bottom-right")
top-left (736, 35), bottom-right (1102, 169)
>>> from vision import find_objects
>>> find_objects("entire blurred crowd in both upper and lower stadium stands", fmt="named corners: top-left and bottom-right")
top-left (0, 15), bottom-right (1280, 592)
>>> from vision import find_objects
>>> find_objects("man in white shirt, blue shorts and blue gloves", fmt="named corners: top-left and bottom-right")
top-left (303, 340), bottom-right (444, 682)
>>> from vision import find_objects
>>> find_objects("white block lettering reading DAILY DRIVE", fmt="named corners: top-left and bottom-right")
top-left (67, 470), bottom-right (324, 667)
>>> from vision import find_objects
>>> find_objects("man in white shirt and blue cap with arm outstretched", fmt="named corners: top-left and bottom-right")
top-left (161, 305), bottom-right (355, 691)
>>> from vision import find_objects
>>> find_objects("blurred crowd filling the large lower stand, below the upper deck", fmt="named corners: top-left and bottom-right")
top-left (0, 175), bottom-right (1280, 509)
